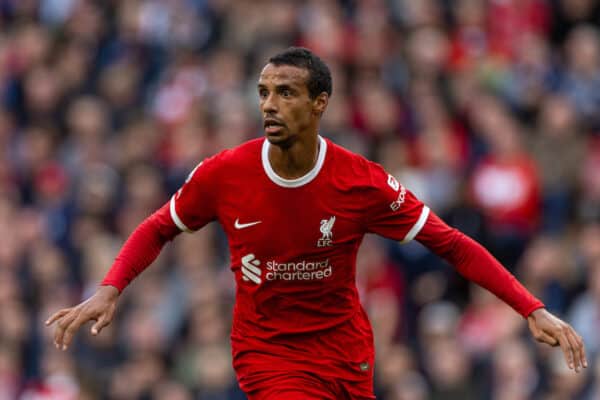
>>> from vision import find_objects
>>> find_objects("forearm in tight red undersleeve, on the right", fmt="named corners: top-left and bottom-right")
top-left (416, 213), bottom-right (544, 317)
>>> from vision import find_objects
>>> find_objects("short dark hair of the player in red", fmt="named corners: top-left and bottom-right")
top-left (269, 47), bottom-right (332, 99)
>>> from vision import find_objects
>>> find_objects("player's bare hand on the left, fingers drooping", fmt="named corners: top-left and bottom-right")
top-left (46, 286), bottom-right (119, 350)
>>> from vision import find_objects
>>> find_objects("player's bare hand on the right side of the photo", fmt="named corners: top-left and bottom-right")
top-left (527, 308), bottom-right (587, 372)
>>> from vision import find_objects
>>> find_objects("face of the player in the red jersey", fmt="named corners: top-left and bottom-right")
top-left (258, 64), bottom-right (327, 146)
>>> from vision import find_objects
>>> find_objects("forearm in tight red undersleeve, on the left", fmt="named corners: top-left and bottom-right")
top-left (101, 204), bottom-right (180, 292)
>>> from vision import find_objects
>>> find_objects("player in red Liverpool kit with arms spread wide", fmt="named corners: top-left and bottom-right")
top-left (47, 48), bottom-right (587, 400)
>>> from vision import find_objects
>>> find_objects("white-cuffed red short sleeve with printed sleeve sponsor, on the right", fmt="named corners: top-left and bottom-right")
top-left (365, 163), bottom-right (429, 243)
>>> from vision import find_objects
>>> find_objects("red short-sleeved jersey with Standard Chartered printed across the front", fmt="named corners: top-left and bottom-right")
top-left (170, 137), bottom-right (429, 390)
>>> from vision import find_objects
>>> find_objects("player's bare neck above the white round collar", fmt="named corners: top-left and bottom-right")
top-left (269, 135), bottom-right (319, 179)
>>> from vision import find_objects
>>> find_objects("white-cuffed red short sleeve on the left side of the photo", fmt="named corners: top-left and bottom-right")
top-left (169, 156), bottom-right (219, 232)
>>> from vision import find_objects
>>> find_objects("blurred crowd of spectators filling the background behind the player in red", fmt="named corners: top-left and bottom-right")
top-left (0, 0), bottom-right (600, 400)
